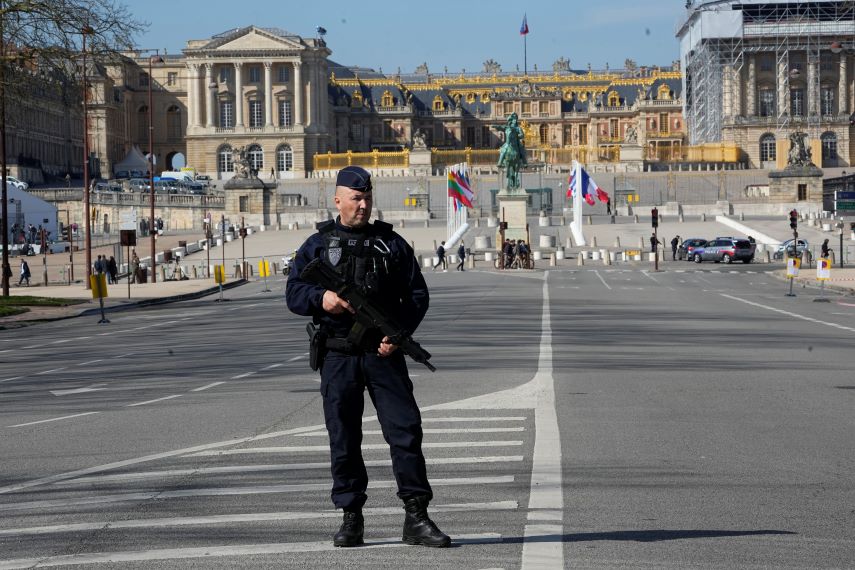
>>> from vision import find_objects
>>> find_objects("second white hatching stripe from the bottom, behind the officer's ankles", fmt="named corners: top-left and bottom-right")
top-left (0, 501), bottom-right (519, 536)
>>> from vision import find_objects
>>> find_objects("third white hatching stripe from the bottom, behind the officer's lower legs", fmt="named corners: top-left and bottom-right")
top-left (0, 475), bottom-right (514, 510)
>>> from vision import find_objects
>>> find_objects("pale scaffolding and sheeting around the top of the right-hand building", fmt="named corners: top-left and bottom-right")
top-left (677, 0), bottom-right (855, 145)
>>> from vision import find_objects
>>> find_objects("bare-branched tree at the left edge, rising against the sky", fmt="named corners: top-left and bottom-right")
top-left (0, 0), bottom-right (147, 297)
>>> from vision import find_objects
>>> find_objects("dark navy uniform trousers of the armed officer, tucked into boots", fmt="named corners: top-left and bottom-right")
top-left (321, 351), bottom-right (433, 509)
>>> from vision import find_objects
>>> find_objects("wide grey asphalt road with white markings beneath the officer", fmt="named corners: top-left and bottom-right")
top-left (0, 263), bottom-right (855, 569)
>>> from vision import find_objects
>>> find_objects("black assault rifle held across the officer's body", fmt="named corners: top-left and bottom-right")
top-left (300, 259), bottom-right (436, 372)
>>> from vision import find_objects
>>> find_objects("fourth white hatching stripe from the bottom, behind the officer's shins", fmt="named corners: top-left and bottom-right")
top-left (54, 455), bottom-right (523, 487)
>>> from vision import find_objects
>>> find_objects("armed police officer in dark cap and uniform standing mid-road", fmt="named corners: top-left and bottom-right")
top-left (285, 166), bottom-right (451, 547)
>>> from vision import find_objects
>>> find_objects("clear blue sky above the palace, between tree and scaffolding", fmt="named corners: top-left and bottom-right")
top-left (128, 0), bottom-right (685, 73)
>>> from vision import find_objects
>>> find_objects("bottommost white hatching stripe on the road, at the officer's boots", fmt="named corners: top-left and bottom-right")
top-left (0, 532), bottom-right (502, 570)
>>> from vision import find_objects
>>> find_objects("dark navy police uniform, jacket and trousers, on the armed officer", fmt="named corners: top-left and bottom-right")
top-left (285, 215), bottom-right (433, 510)
